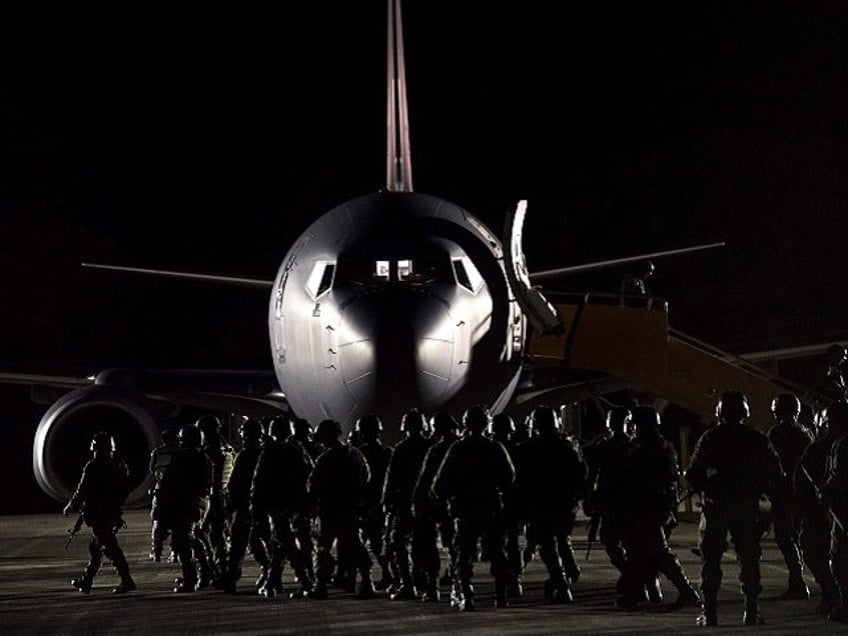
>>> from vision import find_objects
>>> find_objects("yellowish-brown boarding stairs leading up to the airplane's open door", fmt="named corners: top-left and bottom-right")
top-left (527, 294), bottom-right (833, 430)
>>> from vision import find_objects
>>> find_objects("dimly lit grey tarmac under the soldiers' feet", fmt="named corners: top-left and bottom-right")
top-left (0, 510), bottom-right (848, 636)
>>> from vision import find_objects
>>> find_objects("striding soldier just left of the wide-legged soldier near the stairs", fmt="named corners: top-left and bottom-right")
top-left (620, 406), bottom-right (699, 609)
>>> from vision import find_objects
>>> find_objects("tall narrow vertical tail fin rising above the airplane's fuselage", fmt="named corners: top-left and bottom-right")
top-left (386, 0), bottom-right (412, 192)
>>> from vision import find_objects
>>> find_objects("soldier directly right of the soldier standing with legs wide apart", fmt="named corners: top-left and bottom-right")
top-left (766, 393), bottom-right (813, 599)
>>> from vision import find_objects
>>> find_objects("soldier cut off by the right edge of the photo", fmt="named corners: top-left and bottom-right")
top-left (821, 403), bottom-right (848, 623)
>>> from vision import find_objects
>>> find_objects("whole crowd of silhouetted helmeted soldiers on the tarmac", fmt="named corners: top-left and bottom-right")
top-left (65, 391), bottom-right (848, 625)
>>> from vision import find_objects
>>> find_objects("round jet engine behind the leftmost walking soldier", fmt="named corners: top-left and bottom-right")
top-left (32, 385), bottom-right (161, 506)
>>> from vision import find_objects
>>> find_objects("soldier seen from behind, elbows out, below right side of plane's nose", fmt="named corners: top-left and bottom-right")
top-left (433, 406), bottom-right (515, 611)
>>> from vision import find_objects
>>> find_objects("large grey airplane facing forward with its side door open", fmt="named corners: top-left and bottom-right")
top-left (0, 0), bottom-right (836, 503)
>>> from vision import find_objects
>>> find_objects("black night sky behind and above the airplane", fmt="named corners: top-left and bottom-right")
top-left (0, 0), bottom-right (848, 510)
